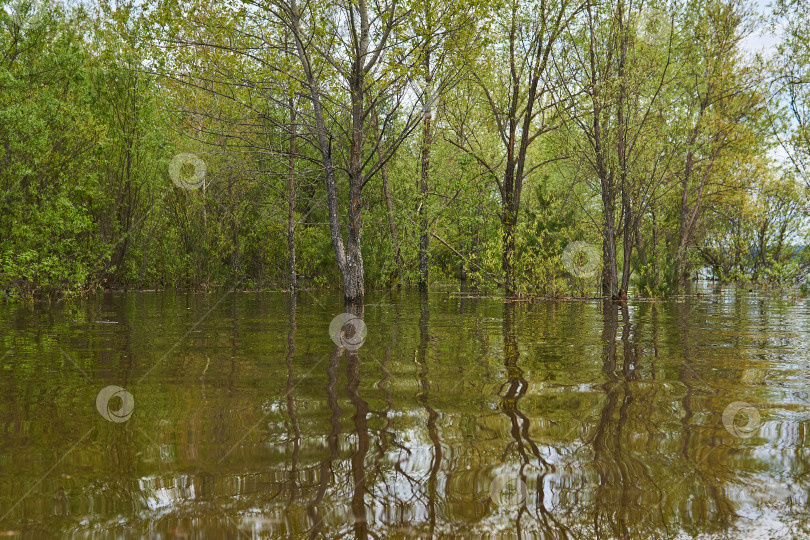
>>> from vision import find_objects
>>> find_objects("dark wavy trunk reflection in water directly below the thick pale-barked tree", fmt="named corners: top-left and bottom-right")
top-left (346, 352), bottom-right (369, 540)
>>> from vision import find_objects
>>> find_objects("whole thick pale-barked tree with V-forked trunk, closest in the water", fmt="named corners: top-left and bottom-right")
top-left (270, 0), bottom-right (426, 302)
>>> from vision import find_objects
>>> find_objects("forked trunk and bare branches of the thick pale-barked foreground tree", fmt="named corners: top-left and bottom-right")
top-left (282, 0), bottom-right (417, 305)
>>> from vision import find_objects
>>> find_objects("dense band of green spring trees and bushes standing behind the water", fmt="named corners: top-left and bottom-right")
top-left (0, 0), bottom-right (810, 298)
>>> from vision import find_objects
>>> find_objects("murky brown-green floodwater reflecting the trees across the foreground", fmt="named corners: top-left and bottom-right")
top-left (0, 284), bottom-right (810, 539)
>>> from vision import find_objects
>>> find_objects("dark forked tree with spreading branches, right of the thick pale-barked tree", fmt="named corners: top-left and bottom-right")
top-left (448, 0), bottom-right (581, 295)
